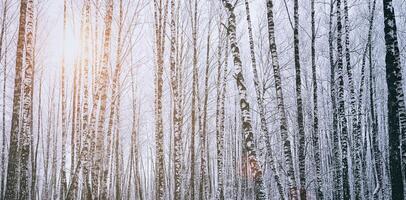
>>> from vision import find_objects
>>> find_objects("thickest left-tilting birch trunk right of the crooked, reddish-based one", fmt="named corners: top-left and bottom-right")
top-left (267, 0), bottom-right (297, 199)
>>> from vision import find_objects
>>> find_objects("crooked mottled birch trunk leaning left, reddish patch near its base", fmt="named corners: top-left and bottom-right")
top-left (223, 0), bottom-right (266, 200)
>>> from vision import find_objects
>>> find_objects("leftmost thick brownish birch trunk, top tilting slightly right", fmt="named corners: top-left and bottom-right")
top-left (5, 0), bottom-right (27, 199)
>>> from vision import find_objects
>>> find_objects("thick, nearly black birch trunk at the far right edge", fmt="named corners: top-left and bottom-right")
top-left (383, 0), bottom-right (406, 199)
